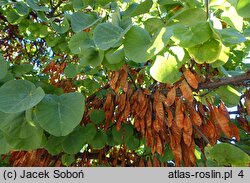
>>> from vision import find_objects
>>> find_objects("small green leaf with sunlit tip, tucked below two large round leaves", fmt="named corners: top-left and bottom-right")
top-left (105, 45), bottom-right (125, 64)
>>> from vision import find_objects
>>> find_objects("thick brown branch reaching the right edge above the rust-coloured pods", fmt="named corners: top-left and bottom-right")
top-left (199, 70), bottom-right (250, 89)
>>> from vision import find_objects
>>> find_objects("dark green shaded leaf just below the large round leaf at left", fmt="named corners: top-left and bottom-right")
top-left (62, 126), bottom-right (87, 154)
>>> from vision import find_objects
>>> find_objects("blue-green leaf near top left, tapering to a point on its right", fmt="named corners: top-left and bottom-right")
top-left (71, 12), bottom-right (99, 32)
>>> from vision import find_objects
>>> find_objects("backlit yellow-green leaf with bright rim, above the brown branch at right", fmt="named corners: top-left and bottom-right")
top-left (187, 39), bottom-right (222, 64)
